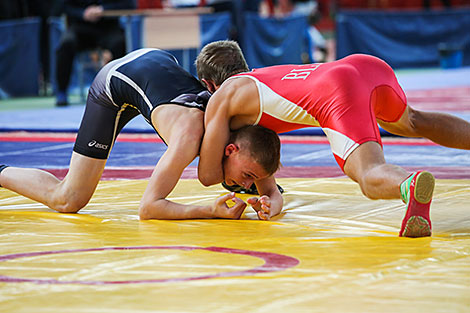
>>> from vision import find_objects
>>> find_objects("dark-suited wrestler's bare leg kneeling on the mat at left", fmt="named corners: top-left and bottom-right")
top-left (0, 152), bottom-right (106, 213)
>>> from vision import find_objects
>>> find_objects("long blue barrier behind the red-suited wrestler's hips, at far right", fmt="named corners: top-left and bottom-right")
top-left (336, 9), bottom-right (470, 68)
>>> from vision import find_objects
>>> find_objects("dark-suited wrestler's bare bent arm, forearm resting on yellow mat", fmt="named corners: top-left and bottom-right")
top-left (139, 105), bottom-right (246, 219)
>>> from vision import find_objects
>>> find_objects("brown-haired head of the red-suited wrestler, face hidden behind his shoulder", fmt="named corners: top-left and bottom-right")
top-left (196, 40), bottom-right (249, 92)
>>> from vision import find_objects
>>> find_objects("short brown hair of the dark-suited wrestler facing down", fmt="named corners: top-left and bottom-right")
top-left (229, 125), bottom-right (281, 175)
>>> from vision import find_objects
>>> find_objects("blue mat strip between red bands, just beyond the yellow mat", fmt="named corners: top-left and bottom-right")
top-left (0, 142), bottom-right (470, 168)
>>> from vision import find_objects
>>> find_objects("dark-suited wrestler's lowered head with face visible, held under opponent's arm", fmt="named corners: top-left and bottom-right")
top-left (223, 126), bottom-right (281, 188)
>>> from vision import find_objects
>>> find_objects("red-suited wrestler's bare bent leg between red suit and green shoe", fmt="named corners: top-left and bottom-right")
top-left (344, 141), bottom-right (409, 199)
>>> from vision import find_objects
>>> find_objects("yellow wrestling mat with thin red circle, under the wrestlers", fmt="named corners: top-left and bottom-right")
top-left (0, 178), bottom-right (470, 313)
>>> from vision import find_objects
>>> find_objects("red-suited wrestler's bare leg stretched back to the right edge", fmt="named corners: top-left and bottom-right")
top-left (378, 106), bottom-right (470, 150)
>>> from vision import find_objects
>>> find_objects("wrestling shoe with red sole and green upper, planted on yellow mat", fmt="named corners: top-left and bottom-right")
top-left (400, 171), bottom-right (435, 237)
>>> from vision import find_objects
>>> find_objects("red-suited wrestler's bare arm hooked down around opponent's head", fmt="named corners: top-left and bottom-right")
top-left (198, 78), bottom-right (259, 186)
